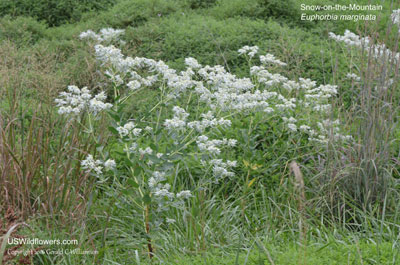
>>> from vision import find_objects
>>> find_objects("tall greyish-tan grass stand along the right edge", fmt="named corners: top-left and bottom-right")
top-left (315, 12), bottom-right (399, 227)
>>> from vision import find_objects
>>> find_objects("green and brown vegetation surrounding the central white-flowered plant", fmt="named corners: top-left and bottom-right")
top-left (0, 0), bottom-right (400, 264)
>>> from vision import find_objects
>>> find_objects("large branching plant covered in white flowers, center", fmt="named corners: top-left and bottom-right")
top-left (56, 29), bottom-right (351, 255)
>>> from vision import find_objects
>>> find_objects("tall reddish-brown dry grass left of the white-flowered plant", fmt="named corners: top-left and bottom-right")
top-left (0, 39), bottom-right (101, 220)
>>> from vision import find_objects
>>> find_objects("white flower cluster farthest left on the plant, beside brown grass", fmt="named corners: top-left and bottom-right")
top-left (55, 86), bottom-right (112, 115)
